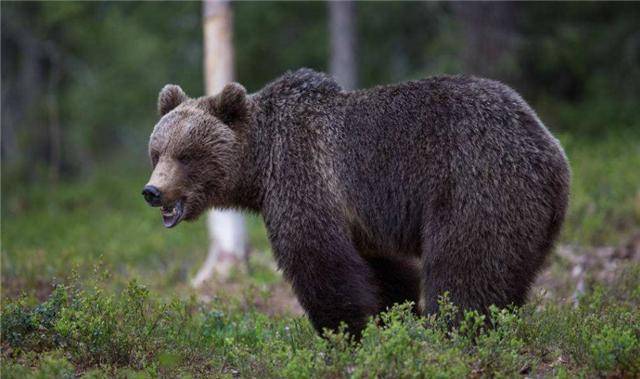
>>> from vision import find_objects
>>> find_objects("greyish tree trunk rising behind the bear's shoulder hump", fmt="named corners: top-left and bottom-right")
top-left (329, 1), bottom-right (358, 90)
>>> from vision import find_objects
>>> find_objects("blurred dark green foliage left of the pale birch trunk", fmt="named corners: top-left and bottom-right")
top-left (2, 2), bottom-right (202, 178)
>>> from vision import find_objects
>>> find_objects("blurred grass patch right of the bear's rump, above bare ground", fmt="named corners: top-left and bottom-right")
top-left (562, 130), bottom-right (640, 245)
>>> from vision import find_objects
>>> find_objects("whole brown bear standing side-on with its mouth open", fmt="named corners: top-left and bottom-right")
top-left (143, 69), bottom-right (570, 335)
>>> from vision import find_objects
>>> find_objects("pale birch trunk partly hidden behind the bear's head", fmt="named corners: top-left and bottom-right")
top-left (192, 0), bottom-right (248, 287)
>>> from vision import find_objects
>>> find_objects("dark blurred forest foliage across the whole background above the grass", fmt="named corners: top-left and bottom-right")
top-left (1, 2), bottom-right (640, 186)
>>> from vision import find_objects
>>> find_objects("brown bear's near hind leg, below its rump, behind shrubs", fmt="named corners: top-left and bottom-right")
top-left (422, 220), bottom-right (544, 322)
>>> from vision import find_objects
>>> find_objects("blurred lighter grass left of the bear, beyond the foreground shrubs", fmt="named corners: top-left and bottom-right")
top-left (2, 167), bottom-right (268, 296)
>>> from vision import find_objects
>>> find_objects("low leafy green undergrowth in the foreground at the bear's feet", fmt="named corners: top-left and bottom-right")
top-left (1, 266), bottom-right (640, 378)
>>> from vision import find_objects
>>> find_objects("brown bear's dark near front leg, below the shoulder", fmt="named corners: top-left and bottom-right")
top-left (267, 215), bottom-right (380, 338)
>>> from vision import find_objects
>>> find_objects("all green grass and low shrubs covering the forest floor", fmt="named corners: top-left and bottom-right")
top-left (0, 129), bottom-right (640, 378)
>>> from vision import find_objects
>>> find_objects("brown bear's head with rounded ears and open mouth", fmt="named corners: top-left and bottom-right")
top-left (142, 83), bottom-right (250, 228)
